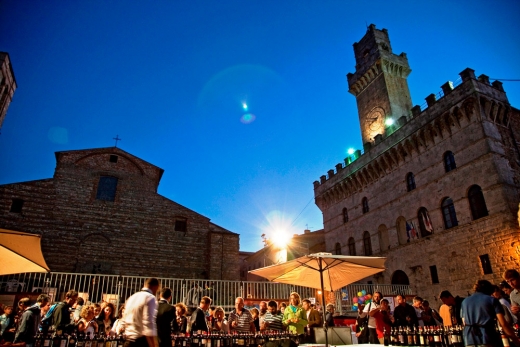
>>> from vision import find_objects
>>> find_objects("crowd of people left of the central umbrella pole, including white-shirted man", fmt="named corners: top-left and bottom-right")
top-left (0, 278), bottom-right (334, 347)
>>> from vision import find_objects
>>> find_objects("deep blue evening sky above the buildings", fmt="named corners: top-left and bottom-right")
top-left (0, 0), bottom-right (520, 251)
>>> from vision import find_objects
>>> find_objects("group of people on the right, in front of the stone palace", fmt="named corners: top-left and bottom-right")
top-left (356, 270), bottom-right (520, 347)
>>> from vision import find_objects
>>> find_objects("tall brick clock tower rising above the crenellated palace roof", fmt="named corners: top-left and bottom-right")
top-left (347, 24), bottom-right (412, 148)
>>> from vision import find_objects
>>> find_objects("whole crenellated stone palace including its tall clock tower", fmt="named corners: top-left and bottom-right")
top-left (314, 25), bottom-right (520, 302)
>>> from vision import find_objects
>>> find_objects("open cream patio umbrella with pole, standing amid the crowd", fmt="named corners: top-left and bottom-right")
top-left (249, 253), bottom-right (386, 346)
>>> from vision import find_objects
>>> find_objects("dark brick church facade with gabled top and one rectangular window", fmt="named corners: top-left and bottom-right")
top-left (0, 147), bottom-right (239, 280)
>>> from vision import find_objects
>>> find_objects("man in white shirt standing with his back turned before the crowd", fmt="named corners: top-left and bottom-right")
top-left (123, 278), bottom-right (160, 347)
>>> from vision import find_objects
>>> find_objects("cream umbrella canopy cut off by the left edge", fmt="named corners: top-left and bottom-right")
top-left (0, 229), bottom-right (50, 275)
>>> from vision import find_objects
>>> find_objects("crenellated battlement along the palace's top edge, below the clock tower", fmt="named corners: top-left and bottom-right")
top-left (314, 68), bottom-right (510, 203)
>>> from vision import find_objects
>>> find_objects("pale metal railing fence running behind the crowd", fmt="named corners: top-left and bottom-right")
top-left (0, 272), bottom-right (412, 311)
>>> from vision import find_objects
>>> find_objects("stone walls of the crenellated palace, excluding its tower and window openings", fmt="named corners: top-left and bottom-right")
top-left (314, 70), bottom-right (520, 307)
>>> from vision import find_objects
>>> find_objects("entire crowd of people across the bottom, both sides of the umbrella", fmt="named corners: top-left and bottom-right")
top-left (0, 270), bottom-right (520, 347)
